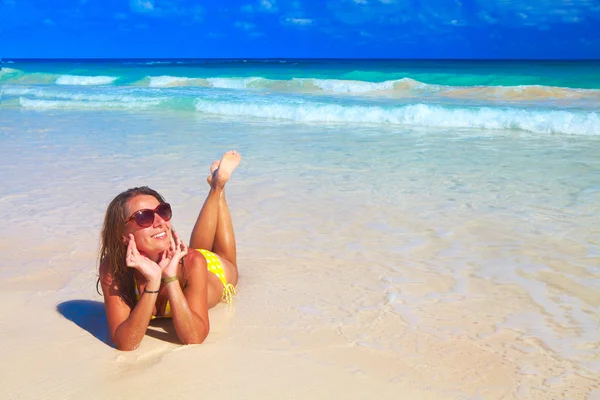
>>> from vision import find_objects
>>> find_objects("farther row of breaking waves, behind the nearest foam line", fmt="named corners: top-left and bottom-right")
top-left (0, 68), bottom-right (600, 109)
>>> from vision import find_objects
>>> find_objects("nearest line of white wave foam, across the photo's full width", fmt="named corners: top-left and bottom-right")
top-left (3, 80), bottom-right (600, 135)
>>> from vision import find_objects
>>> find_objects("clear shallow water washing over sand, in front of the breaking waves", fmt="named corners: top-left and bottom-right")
top-left (0, 108), bottom-right (600, 388)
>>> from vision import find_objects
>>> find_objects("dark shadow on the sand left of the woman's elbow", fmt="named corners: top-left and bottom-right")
top-left (56, 300), bottom-right (114, 347)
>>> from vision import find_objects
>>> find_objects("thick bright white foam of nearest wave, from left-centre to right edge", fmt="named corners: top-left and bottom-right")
top-left (196, 99), bottom-right (600, 135)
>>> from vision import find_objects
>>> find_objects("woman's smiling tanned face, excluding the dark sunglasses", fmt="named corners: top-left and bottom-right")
top-left (123, 195), bottom-right (171, 258)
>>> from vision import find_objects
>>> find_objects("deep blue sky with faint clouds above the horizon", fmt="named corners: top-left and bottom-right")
top-left (0, 0), bottom-right (600, 58)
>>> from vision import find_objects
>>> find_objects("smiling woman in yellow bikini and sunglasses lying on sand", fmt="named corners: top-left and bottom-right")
top-left (99, 151), bottom-right (241, 350)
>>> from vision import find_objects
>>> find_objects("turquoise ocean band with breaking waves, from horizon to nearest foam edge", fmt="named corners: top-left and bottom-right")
top-left (0, 60), bottom-right (600, 135)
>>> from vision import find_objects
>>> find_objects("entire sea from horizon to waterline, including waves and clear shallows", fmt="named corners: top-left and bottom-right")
top-left (0, 60), bottom-right (600, 390)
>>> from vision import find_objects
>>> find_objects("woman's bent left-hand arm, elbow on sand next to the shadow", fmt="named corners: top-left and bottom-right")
top-left (100, 263), bottom-right (160, 350)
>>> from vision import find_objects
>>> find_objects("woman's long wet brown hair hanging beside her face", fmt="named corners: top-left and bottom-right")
top-left (96, 186), bottom-right (165, 307)
